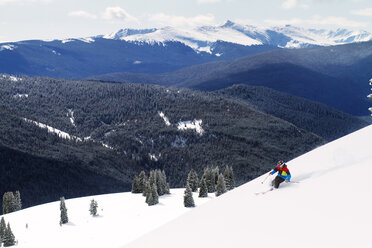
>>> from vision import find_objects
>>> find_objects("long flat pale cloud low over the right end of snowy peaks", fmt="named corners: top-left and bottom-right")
top-left (264, 16), bottom-right (368, 28)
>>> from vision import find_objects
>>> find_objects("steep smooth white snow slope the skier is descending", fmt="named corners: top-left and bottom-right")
top-left (124, 126), bottom-right (372, 248)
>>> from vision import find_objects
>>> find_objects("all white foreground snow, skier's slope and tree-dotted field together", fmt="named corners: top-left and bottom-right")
top-left (4, 126), bottom-right (372, 248)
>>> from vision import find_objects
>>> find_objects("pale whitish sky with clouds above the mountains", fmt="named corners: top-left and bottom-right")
top-left (0, 0), bottom-right (372, 42)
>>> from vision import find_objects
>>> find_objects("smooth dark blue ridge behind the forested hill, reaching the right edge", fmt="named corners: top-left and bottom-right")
top-left (92, 41), bottom-right (372, 116)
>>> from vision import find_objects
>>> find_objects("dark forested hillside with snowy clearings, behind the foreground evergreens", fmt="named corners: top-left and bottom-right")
top-left (0, 75), bottom-right (324, 209)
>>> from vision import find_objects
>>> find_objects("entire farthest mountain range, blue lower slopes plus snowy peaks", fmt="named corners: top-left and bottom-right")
top-left (0, 21), bottom-right (372, 79)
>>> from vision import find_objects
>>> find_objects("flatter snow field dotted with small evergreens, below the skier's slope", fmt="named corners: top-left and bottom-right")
top-left (4, 189), bottom-right (214, 248)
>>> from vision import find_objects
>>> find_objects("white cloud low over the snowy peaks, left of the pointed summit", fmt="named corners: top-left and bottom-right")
top-left (149, 13), bottom-right (215, 26)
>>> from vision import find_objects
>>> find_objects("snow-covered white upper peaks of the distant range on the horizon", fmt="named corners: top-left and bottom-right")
top-left (104, 21), bottom-right (372, 53)
